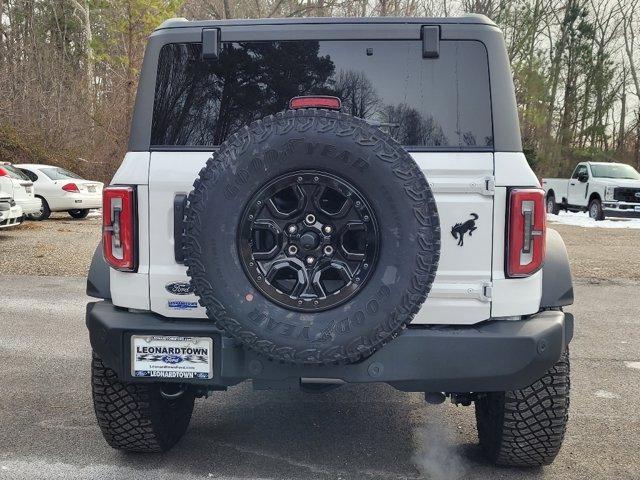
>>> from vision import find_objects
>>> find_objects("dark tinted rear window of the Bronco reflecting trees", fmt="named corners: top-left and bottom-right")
top-left (151, 40), bottom-right (493, 149)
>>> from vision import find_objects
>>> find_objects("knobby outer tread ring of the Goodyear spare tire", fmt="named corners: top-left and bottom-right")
top-left (183, 109), bottom-right (440, 365)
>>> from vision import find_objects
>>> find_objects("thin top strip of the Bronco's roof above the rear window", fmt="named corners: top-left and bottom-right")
top-left (156, 14), bottom-right (495, 30)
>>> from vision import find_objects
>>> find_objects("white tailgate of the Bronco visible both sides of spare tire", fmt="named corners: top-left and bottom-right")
top-left (149, 152), bottom-right (493, 324)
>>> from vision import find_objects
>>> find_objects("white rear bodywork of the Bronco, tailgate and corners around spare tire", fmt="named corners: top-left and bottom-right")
top-left (111, 147), bottom-right (542, 324)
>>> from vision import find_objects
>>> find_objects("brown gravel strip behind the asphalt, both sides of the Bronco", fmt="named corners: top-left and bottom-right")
top-left (0, 213), bottom-right (640, 280)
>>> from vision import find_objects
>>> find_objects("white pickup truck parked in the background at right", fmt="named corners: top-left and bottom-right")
top-left (542, 162), bottom-right (640, 220)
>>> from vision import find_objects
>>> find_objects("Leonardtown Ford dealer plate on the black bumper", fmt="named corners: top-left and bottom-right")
top-left (131, 335), bottom-right (213, 380)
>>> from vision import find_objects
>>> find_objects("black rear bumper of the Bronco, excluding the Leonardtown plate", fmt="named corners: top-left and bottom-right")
top-left (87, 301), bottom-right (573, 392)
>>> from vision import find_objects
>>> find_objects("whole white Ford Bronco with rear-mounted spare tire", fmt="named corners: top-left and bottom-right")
top-left (86, 16), bottom-right (573, 466)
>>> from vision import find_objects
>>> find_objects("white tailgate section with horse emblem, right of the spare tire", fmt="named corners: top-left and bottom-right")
top-left (412, 153), bottom-right (494, 324)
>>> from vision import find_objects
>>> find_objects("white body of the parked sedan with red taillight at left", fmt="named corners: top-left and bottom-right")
top-left (16, 164), bottom-right (103, 213)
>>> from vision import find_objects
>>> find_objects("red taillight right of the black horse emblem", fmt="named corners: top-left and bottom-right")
top-left (507, 188), bottom-right (547, 277)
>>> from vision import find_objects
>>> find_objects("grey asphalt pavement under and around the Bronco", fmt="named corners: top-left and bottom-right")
top-left (0, 275), bottom-right (640, 480)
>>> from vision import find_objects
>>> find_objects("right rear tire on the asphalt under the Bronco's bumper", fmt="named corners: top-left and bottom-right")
top-left (475, 350), bottom-right (570, 467)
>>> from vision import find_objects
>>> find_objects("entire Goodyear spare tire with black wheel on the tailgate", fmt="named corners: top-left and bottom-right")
top-left (184, 109), bottom-right (440, 365)
